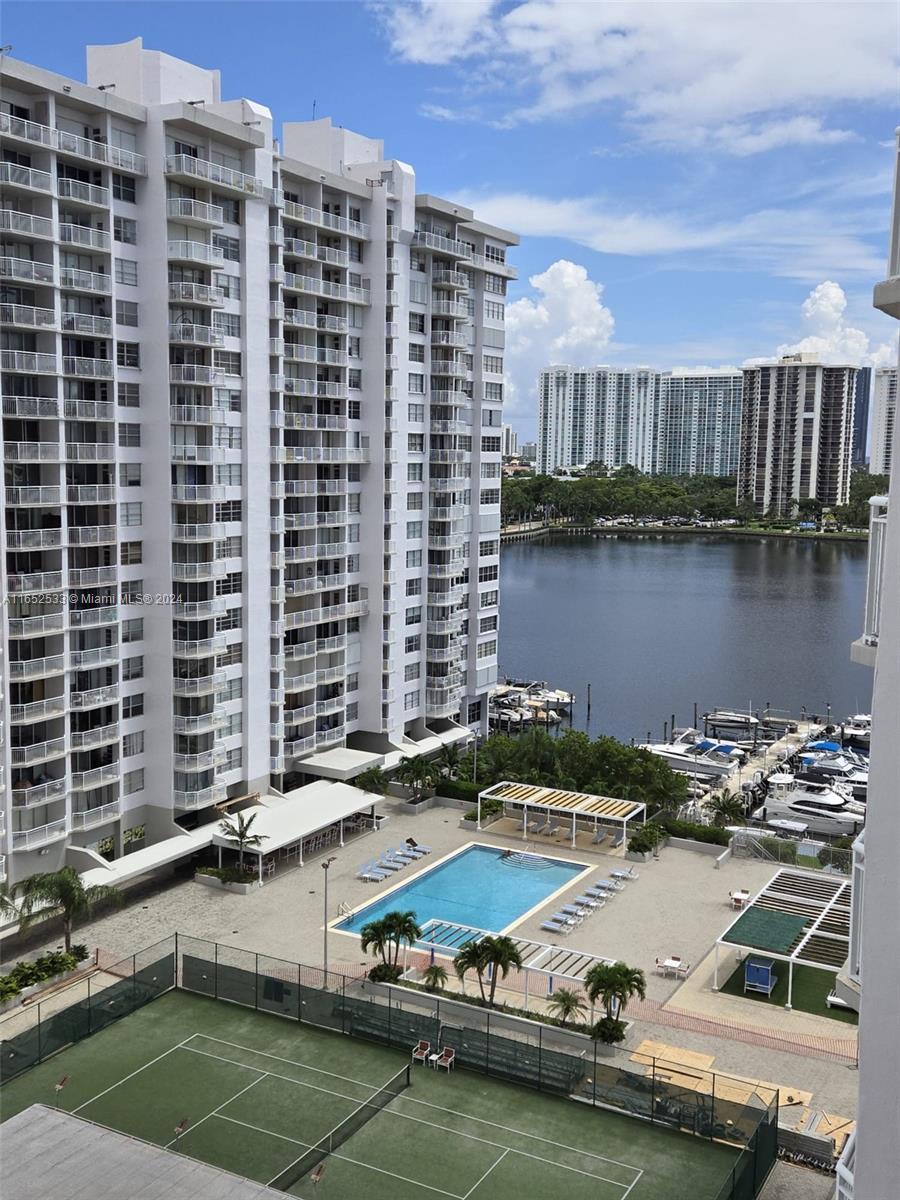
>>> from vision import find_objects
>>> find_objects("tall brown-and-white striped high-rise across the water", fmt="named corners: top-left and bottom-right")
top-left (737, 354), bottom-right (857, 516)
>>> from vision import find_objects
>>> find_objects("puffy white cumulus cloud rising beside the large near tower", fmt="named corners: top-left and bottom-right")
top-left (504, 258), bottom-right (616, 418)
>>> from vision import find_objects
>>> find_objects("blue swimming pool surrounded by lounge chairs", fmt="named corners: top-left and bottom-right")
top-left (335, 846), bottom-right (587, 934)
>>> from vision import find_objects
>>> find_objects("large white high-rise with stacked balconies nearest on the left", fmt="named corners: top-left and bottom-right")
top-left (0, 40), bottom-right (517, 880)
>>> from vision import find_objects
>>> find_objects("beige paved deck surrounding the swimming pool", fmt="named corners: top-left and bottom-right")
top-left (7, 800), bottom-right (857, 1116)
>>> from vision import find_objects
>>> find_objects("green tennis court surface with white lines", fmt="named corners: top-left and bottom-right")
top-left (0, 992), bottom-right (737, 1200)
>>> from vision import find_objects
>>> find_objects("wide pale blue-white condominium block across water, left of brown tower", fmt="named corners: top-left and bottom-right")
top-left (538, 366), bottom-right (742, 475)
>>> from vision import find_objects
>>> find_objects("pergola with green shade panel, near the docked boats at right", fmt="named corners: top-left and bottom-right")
top-left (713, 871), bottom-right (853, 1008)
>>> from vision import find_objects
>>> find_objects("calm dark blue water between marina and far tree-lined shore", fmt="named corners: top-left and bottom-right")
top-left (500, 536), bottom-right (872, 740)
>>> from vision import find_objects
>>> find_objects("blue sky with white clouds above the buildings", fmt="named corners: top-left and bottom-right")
top-left (8, 0), bottom-right (900, 433)
